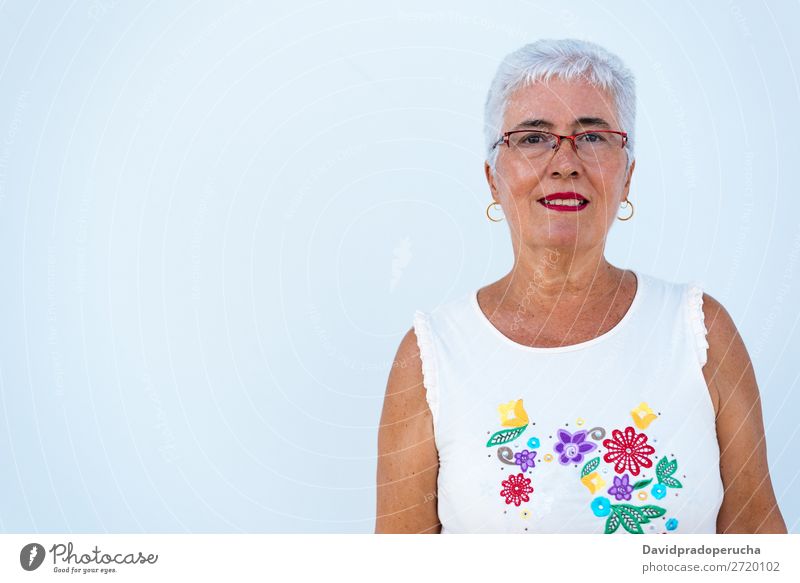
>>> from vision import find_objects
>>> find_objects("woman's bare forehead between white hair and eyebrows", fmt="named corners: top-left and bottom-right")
top-left (503, 78), bottom-right (620, 129)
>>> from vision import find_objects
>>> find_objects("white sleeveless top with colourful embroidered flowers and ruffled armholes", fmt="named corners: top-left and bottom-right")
top-left (414, 270), bottom-right (723, 534)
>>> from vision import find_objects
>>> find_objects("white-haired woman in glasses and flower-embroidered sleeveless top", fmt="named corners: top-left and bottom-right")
top-left (376, 40), bottom-right (786, 534)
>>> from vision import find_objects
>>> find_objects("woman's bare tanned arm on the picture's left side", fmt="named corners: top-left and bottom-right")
top-left (375, 328), bottom-right (441, 534)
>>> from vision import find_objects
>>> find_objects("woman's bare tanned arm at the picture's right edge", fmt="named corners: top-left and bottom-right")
top-left (703, 294), bottom-right (786, 534)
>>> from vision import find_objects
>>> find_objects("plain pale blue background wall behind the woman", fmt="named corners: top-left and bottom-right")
top-left (0, 0), bottom-right (800, 532)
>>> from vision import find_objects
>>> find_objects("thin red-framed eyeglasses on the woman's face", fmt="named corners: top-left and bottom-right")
top-left (492, 130), bottom-right (628, 164)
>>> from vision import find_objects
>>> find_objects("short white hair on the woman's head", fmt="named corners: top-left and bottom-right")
top-left (484, 39), bottom-right (636, 169)
